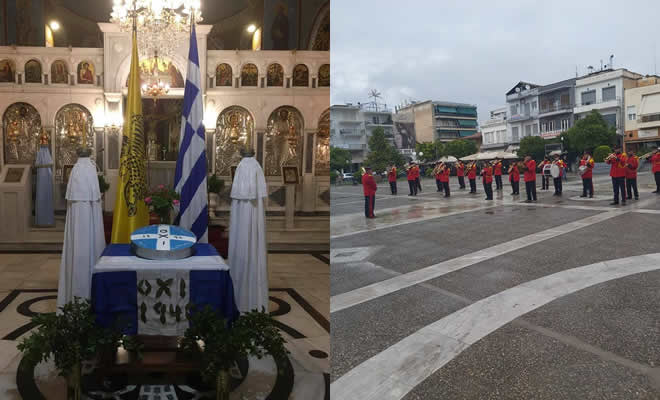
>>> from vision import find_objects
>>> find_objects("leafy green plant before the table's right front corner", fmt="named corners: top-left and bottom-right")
top-left (182, 306), bottom-right (287, 400)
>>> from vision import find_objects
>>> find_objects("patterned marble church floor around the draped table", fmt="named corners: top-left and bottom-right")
top-left (0, 252), bottom-right (330, 400)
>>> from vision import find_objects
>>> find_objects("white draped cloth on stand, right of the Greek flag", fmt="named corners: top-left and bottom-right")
top-left (228, 157), bottom-right (268, 312)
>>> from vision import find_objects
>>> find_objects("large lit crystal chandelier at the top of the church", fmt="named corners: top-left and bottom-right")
top-left (110, 0), bottom-right (202, 56)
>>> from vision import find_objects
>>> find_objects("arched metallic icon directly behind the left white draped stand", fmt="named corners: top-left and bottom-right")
top-left (54, 103), bottom-right (96, 183)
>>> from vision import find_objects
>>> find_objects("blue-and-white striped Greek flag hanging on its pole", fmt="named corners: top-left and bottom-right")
top-left (174, 25), bottom-right (208, 243)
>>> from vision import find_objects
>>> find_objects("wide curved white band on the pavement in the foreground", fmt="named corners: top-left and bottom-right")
top-left (330, 253), bottom-right (660, 400)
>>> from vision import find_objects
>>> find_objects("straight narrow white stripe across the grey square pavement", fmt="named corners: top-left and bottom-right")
top-left (330, 210), bottom-right (629, 313)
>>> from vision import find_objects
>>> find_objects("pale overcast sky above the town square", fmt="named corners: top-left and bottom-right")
top-left (331, 0), bottom-right (660, 121)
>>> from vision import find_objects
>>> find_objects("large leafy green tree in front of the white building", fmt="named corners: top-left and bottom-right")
top-left (561, 110), bottom-right (616, 154)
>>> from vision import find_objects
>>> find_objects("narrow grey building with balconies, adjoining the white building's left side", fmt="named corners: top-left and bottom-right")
top-left (538, 78), bottom-right (575, 139)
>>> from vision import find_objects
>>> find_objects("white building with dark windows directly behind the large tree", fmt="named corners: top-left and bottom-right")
top-left (573, 68), bottom-right (642, 142)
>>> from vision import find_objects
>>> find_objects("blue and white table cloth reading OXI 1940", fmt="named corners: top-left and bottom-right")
top-left (92, 243), bottom-right (239, 336)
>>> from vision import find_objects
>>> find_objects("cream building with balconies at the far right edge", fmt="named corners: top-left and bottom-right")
top-left (624, 76), bottom-right (660, 150)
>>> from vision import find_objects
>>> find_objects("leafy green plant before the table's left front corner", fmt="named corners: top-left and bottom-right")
top-left (18, 297), bottom-right (119, 400)
